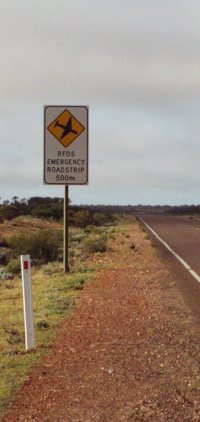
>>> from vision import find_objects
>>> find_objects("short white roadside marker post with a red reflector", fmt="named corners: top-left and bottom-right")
top-left (21, 255), bottom-right (35, 350)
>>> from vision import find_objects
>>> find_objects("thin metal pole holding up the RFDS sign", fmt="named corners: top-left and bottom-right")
top-left (63, 185), bottom-right (69, 273)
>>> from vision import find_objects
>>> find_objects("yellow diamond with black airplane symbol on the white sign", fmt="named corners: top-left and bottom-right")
top-left (47, 110), bottom-right (85, 148)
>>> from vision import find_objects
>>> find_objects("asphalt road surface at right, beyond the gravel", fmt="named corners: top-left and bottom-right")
top-left (142, 215), bottom-right (200, 321)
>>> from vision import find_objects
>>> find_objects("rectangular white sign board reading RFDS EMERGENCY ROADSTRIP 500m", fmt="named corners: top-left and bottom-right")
top-left (44, 106), bottom-right (88, 185)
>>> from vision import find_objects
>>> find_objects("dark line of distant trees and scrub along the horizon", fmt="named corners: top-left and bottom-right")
top-left (0, 196), bottom-right (200, 226)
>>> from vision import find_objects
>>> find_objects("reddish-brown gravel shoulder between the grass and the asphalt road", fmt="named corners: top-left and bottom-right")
top-left (2, 223), bottom-right (200, 422)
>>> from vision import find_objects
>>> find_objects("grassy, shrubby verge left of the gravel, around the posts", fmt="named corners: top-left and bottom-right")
top-left (0, 199), bottom-right (122, 415)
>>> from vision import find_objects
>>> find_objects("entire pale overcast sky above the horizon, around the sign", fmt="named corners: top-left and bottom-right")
top-left (0, 0), bottom-right (200, 204)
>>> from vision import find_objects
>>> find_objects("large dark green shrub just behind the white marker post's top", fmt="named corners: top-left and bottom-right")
top-left (8, 231), bottom-right (60, 263)
